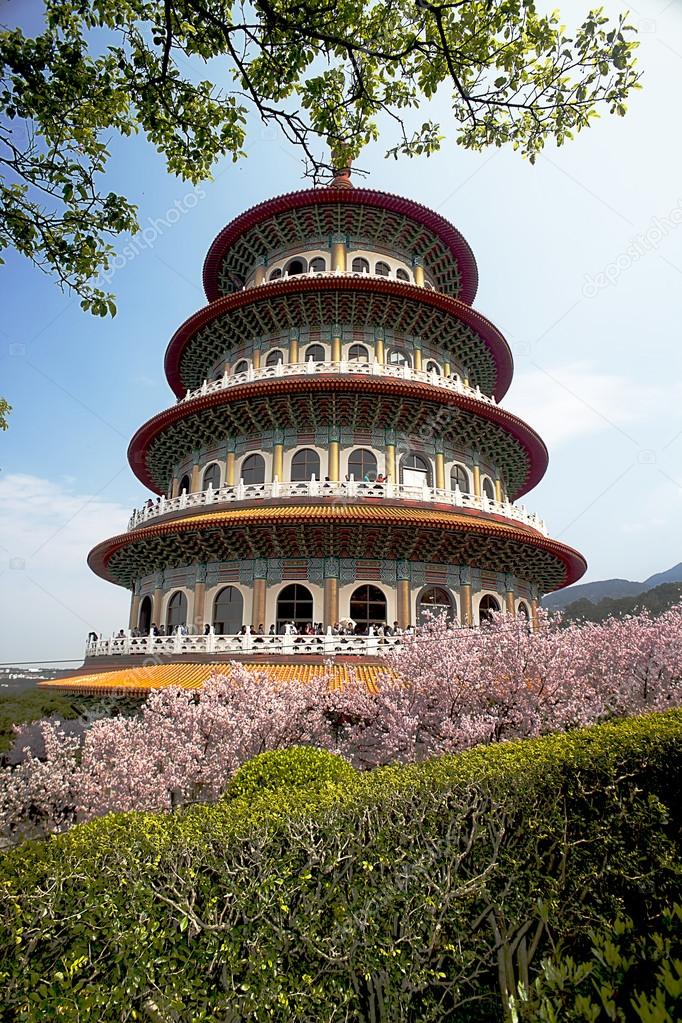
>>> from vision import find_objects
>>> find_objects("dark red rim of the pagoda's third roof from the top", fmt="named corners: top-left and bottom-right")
top-left (128, 373), bottom-right (549, 500)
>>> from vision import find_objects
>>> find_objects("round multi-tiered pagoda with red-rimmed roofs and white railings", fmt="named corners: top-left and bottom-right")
top-left (65, 172), bottom-right (586, 691)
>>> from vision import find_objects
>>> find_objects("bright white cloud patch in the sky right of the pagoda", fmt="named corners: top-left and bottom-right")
top-left (504, 359), bottom-right (672, 450)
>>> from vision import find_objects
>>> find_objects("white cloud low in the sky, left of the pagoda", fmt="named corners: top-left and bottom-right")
top-left (0, 474), bottom-right (130, 662)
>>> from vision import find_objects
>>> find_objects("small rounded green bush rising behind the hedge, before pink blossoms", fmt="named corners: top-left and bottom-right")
top-left (225, 746), bottom-right (354, 799)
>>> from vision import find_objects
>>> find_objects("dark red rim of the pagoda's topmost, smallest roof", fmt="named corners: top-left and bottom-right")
top-left (203, 188), bottom-right (479, 304)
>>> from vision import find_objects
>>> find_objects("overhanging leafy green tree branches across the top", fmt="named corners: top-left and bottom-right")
top-left (0, 0), bottom-right (637, 315)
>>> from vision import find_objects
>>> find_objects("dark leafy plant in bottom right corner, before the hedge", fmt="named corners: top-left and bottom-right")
top-left (518, 903), bottom-right (682, 1023)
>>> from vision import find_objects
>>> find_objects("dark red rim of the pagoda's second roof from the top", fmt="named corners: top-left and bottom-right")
top-left (164, 274), bottom-right (513, 401)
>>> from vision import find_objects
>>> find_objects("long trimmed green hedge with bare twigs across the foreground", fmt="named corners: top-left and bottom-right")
top-left (0, 712), bottom-right (682, 1023)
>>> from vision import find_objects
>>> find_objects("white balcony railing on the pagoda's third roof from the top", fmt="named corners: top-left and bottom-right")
top-left (179, 359), bottom-right (497, 405)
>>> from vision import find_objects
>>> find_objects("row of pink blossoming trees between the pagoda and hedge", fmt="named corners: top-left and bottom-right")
top-left (0, 606), bottom-right (682, 843)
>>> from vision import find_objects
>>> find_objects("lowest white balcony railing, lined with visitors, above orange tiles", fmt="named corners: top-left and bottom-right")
top-left (85, 632), bottom-right (401, 660)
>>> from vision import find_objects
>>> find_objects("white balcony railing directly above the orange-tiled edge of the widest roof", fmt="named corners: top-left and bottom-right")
top-left (128, 479), bottom-right (547, 536)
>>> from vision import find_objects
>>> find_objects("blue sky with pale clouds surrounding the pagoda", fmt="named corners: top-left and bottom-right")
top-left (0, 0), bottom-right (682, 662)
